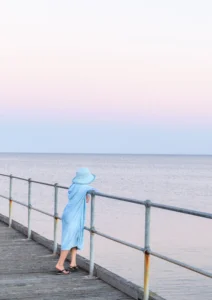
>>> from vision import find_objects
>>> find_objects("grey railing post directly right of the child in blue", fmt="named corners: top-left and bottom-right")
top-left (89, 194), bottom-right (95, 277)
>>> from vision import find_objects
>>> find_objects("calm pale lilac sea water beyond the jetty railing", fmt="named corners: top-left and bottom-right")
top-left (0, 154), bottom-right (212, 300)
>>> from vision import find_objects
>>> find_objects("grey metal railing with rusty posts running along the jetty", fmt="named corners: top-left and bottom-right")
top-left (0, 174), bottom-right (212, 300)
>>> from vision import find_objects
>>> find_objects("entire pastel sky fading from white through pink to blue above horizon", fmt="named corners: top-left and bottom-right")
top-left (0, 0), bottom-right (212, 154)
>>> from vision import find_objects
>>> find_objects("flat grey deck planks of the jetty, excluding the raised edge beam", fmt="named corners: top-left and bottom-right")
top-left (0, 221), bottom-right (132, 300)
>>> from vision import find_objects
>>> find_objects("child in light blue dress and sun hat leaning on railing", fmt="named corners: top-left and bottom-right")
top-left (56, 168), bottom-right (96, 275)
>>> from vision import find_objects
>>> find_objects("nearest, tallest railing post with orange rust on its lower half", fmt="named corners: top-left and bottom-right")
top-left (143, 200), bottom-right (151, 300)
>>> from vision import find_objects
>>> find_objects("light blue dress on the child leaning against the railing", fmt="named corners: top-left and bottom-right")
top-left (61, 184), bottom-right (94, 250)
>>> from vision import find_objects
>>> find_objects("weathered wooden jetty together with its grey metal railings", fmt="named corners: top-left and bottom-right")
top-left (0, 174), bottom-right (212, 300)
